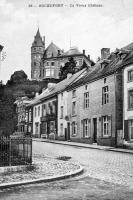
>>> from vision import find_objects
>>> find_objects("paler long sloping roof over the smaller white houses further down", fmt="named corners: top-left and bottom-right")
top-left (28, 69), bottom-right (86, 106)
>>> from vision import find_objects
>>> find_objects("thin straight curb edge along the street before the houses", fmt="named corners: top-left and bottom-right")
top-left (33, 139), bottom-right (133, 154)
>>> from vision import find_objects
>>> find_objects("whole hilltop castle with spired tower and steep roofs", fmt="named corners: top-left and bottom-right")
top-left (31, 29), bottom-right (94, 80)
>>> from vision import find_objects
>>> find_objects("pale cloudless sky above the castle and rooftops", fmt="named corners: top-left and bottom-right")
top-left (0, 0), bottom-right (133, 83)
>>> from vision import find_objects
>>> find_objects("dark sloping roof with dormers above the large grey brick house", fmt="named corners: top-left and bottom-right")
top-left (67, 44), bottom-right (133, 90)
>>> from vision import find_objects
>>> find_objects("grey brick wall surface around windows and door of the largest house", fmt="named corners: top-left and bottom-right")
top-left (68, 75), bottom-right (116, 146)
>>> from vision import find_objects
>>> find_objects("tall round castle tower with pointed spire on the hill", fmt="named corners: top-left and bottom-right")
top-left (31, 28), bottom-right (45, 80)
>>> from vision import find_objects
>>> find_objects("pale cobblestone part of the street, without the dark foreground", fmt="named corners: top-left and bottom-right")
top-left (33, 142), bottom-right (133, 189)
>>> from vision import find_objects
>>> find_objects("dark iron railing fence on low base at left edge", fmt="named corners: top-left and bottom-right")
top-left (0, 136), bottom-right (32, 167)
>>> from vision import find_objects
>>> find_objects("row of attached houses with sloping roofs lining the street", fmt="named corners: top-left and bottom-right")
top-left (15, 44), bottom-right (133, 146)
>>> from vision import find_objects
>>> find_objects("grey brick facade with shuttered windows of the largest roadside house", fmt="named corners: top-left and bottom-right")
top-left (65, 71), bottom-right (122, 146)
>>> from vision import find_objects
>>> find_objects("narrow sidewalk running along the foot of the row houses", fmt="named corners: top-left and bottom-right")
top-left (33, 138), bottom-right (133, 154)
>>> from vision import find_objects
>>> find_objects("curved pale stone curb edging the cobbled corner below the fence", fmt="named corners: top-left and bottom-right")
top-left (0, 166), bottom-right (84, 189)
